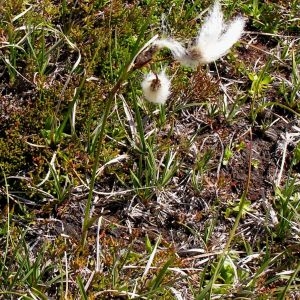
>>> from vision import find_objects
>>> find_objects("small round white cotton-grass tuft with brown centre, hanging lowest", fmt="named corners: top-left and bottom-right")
top-left (142, 71), bottom-right (171, 104)
